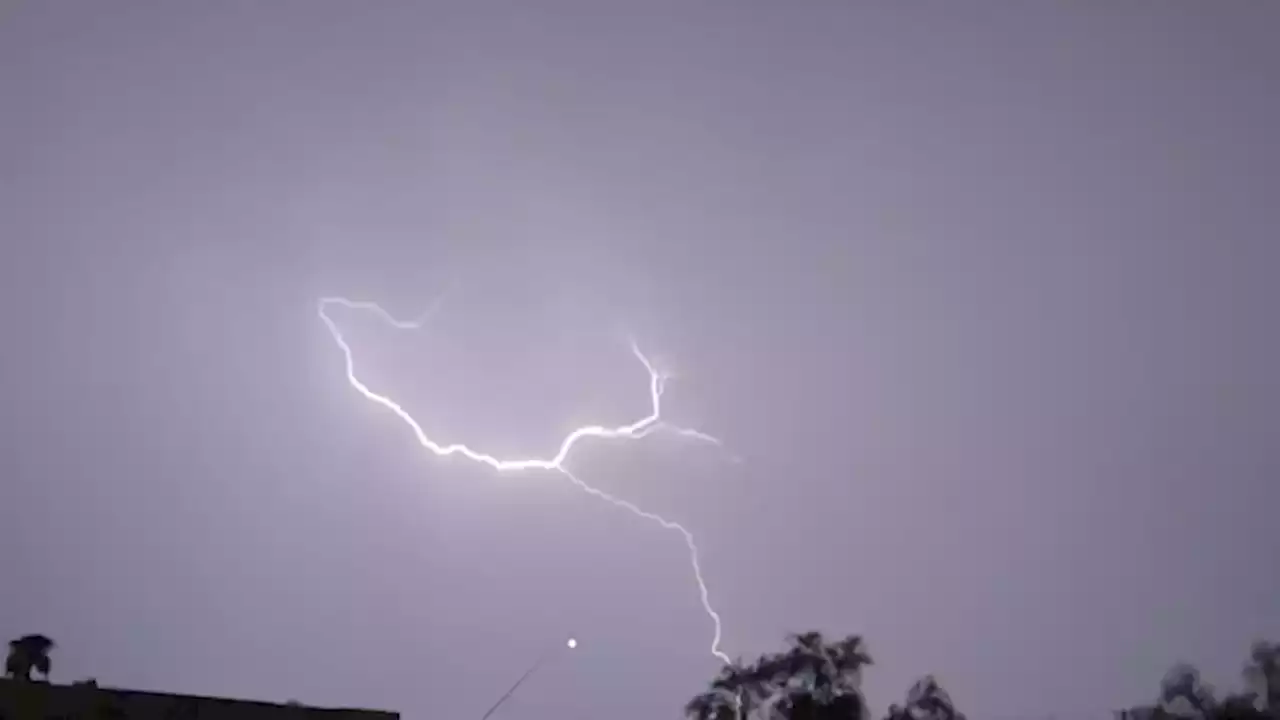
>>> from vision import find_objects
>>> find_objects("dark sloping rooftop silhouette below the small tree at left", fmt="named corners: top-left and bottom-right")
top-left (0, 679), bottom-right (399, 720)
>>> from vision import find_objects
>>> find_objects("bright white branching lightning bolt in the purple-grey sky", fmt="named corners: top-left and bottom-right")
top-left (316, 297), bottom-right (730, 665)
